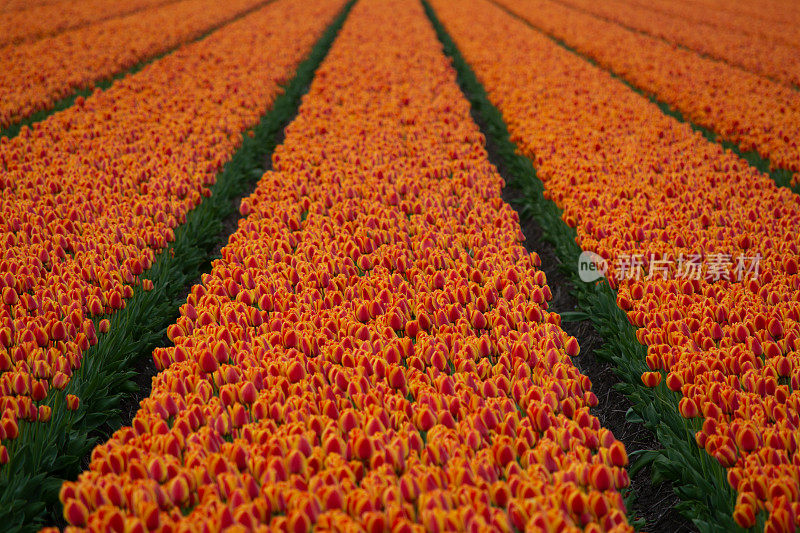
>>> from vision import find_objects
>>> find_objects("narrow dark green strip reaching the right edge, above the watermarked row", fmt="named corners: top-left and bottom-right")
top-left (488, 0), bottom-right (800, 194)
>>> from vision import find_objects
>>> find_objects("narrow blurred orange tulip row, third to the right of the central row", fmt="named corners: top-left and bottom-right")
top-left (559, 0), bottom-right (800, 86)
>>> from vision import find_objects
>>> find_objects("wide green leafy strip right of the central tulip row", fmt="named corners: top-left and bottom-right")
top-left (422, 0), bottom-right (765, 532)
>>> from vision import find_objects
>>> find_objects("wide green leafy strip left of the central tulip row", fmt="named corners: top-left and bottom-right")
top-left (0, 0), bottom-right (355, 532)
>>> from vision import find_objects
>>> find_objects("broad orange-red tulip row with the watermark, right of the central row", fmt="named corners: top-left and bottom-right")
top-left (433, 0), bottom-right (800, 531)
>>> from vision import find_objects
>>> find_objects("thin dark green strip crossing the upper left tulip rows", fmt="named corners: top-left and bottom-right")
top-left (0, 0), bottom-right (275, 139)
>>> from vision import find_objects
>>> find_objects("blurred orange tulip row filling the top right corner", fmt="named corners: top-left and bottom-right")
top-left (608, 0), bottom-right (800, 52)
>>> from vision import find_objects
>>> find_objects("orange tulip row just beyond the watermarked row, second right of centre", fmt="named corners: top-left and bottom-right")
top-left (488, 0), bottom-right (800, 185)
